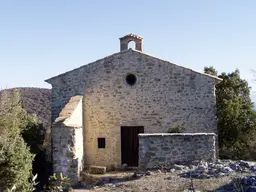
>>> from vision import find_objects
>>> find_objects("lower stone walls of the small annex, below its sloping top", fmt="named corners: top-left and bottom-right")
top-left (52, 125), bottom-right (83, 184)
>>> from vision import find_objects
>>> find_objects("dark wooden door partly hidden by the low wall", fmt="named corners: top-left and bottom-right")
top-left (121, 126), bottom-right (144, 166)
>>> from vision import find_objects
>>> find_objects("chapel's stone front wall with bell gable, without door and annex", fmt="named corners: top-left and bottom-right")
top-left (46, 35), bottom-right (221, 174)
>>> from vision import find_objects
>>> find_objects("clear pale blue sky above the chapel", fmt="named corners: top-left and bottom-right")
top-left (0, 0), bottom-right (256, 100)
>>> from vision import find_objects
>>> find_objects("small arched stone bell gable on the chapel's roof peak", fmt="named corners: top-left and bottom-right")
top-left (119, 33), bottom-right (143, 51)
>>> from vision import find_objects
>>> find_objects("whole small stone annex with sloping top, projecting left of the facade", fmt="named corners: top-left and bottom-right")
top-left (52, 96), bottom-right (83, 184)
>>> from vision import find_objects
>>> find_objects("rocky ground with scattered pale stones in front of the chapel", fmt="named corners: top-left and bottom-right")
top-left (73, 160), bottom-right (256, 192)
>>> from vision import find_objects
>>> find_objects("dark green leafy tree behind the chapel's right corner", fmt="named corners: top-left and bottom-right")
top-left (204, 67), bottom-right (256, 160)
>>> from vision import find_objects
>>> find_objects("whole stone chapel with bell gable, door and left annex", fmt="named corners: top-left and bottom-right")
top-left (46, 34), bottom-right (221, 184)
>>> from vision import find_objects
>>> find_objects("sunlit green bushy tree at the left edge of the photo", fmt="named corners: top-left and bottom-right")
top-left (0, 91), bottom-right (34, 192)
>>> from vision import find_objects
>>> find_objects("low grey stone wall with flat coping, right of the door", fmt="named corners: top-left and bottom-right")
top-left (139, 133), bottom-right (216, 169)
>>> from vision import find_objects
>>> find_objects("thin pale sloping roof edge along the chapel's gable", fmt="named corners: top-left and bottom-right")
top-left (45, 49), bottom-right (222, 84)
